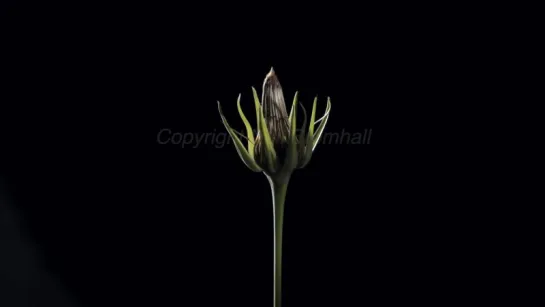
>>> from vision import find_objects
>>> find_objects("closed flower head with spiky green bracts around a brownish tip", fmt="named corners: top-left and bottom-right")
top-left (218, 68), bottom-right (331, 181)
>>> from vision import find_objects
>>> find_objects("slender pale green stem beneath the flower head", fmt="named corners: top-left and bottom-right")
top-left (267, 176), bottom-right (288, 307)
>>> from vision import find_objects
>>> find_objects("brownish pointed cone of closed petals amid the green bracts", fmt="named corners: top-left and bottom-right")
top-left (255, 68), bottom-right (290, 172)
